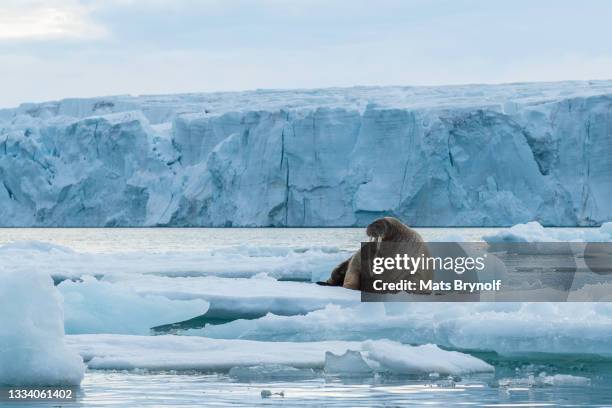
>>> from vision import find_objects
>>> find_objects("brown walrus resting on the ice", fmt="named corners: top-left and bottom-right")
top-left (317, 217), bottom-right (432, 290)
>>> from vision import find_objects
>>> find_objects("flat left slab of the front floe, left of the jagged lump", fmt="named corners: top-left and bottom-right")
top-left (67, 334), bottom-right (361, 372)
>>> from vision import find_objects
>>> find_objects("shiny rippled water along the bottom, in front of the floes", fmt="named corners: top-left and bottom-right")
top-left (7, 371), bottom-right (612, 407)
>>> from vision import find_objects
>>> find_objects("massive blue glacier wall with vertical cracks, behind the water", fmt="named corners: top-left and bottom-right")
top-left (0, 81), bottom-right (612, 227)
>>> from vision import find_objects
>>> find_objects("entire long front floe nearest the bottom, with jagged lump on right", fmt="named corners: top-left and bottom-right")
top-left (68, 334), bottom-right (493, 377)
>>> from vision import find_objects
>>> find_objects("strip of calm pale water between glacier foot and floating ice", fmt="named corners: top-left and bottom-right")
top-left (0, 228), bottom-right (592, 252)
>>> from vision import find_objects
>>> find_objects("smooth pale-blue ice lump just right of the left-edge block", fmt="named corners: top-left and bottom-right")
top-left (58, 276), bottom-right (209, 334)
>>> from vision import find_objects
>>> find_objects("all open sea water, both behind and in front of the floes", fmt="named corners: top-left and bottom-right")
top-left (0, 228), bottom-right (612, 407)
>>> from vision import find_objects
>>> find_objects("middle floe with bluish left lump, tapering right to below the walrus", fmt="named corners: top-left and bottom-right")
top-left (58, 274), bottom-right (360, 334)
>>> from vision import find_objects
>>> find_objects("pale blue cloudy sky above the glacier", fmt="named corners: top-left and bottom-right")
top-left (0, 0), bottom-right (612, 107)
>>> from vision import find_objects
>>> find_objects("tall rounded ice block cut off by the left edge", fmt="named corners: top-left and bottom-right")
top-left (0, 269), bottom-right (85, 386)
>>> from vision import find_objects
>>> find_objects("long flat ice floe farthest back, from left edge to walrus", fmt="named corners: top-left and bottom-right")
top-left (0, 241), bottom-right (348, 281)
